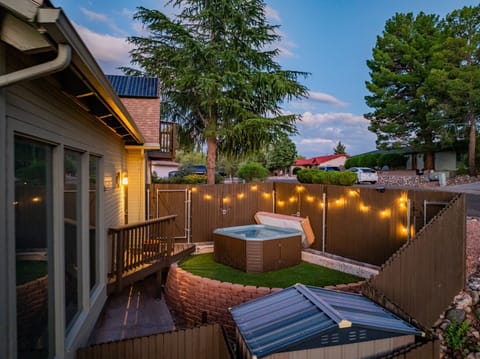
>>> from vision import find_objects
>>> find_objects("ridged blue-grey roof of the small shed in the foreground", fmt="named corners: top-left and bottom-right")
top-left (230, 284), bottom-right (423, 358)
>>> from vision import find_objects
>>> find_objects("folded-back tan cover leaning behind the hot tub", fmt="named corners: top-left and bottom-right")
top-left (255, 212), bottom-right (315, 248)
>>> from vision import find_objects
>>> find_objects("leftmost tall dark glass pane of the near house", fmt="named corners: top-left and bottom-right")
top-left (14, 137), bottom-right (53, 358)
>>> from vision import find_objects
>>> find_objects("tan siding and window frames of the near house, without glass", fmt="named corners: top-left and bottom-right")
top-left (0, 44), bottom-right (126, 358)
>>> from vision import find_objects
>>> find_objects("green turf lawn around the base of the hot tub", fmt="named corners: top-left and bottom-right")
top-left (179, 253), bottom-right (362, 288)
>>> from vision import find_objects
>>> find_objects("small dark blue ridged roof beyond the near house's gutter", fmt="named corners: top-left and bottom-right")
top-left (107, 75), bottom-right (159, 98)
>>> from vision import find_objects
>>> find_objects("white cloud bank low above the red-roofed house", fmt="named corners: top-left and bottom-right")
top-left (293, 112), bottom-right (376, 158)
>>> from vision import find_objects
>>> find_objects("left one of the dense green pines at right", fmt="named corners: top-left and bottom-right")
top-left (365, 13), bottom-right (443, 169)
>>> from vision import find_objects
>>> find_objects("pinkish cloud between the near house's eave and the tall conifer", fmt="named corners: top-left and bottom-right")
top-left (74, 23), bottom-right (132, 73)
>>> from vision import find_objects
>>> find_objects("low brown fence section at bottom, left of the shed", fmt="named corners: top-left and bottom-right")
top-left (77, 324), bottom-right (232, 359)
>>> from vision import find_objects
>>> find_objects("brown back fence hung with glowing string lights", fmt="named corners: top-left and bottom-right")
top-left (149, 182), bottom-right (455, 265)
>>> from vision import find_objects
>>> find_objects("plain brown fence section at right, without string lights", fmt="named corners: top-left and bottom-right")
top-left (363, 195), bottom-right (466, 328)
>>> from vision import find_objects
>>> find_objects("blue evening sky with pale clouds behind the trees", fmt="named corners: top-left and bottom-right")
top-left (52, 0), bottom-right (478, 158)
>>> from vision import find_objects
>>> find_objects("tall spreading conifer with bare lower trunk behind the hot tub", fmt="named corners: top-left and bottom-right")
top-left (124, 0), bottom-right (307, 183)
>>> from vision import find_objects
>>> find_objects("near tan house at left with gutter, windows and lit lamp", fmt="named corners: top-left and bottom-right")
top-left (0, 0), bottom-right (161, 359)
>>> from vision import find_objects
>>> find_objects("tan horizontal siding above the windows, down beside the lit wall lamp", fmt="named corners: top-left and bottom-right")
top-left (7, 81), bottom-right (126, 229)
